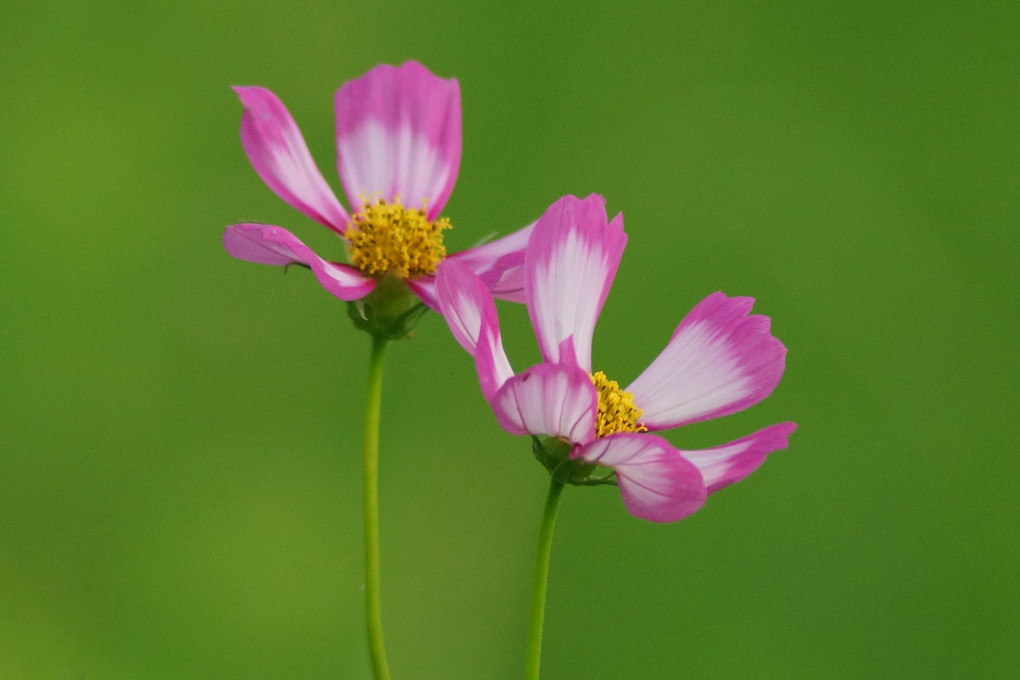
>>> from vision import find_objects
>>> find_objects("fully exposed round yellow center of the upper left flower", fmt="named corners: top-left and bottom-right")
top-left (344, 199), bottom-right (451, 278)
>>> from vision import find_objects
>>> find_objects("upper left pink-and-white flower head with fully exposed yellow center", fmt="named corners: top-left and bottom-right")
top-left (223, 61), bottom-right (533, 309)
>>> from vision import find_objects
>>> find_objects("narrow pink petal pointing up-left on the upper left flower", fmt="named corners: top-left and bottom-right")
top-left (234, 88), bottom-right (350, 232)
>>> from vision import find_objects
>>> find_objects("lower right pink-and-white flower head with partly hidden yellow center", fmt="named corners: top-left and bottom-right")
top-left (438, 195), bottom-right (797, 522)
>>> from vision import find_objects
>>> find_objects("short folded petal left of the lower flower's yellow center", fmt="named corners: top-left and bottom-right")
top-left (490, 364), bottom-right (598, 443)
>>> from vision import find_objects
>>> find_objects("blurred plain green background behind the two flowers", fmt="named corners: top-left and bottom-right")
top-left (0, 0), bottom-right (1020, 680)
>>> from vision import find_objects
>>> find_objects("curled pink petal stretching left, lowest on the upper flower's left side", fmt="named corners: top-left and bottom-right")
top-left (223, 223), bottom-right (375, 300)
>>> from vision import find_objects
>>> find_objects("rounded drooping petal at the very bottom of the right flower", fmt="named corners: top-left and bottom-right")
top-left (571, 432), bottom-right (708, 522)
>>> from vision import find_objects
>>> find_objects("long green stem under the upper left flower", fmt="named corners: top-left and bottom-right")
top-left (364, 336), bottom-right (390, 680)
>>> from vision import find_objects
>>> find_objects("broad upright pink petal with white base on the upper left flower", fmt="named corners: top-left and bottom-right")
top-left (336, 61), bottom-right (461, 219)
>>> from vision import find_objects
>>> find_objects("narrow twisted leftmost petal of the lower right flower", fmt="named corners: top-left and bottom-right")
top-left (436, 260), bottom-right (513, 401)
